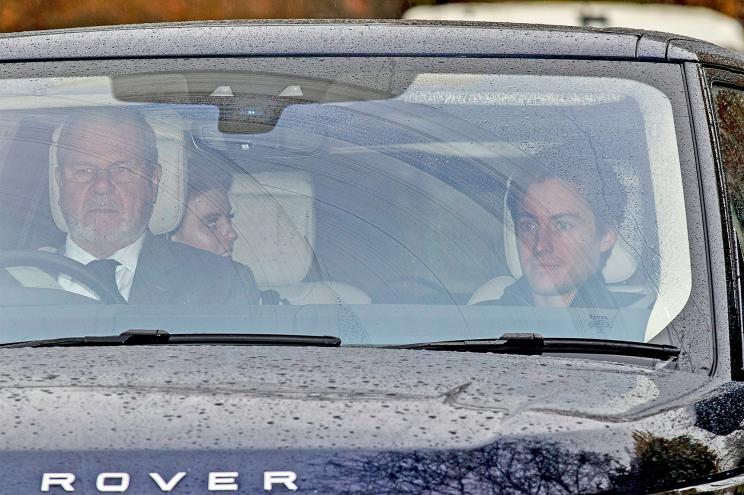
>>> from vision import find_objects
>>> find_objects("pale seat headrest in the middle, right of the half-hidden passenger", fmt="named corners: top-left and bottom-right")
top-left (230, 172), bottom-right (315, 289)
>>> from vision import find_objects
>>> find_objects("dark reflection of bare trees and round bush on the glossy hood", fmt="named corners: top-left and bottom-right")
top-left (317, 433), bottom-right (720, 495)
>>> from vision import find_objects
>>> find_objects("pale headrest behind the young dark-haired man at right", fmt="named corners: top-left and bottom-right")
top-left (504, 182), bottom-right (638, 284)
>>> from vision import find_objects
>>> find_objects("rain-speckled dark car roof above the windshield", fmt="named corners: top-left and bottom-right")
top-left (0, 20), bottom-right (744, 70)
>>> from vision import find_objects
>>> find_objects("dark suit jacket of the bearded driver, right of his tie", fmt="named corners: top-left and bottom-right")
top-left (116, 233), bottom-right (258, 306)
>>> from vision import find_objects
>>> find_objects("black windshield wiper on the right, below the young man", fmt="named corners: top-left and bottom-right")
top-left (382, 333), bottom-right (680, 360)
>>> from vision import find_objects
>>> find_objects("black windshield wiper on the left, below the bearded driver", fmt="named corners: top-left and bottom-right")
top-left (0, 330), bottom-right (341, 348)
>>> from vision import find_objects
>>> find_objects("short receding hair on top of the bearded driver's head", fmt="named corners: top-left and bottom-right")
top-left (56, 107), bottom-right (158, 168)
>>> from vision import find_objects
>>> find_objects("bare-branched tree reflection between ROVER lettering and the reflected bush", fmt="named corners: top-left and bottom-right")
top-left (327, 441), bottom-right (625, 494)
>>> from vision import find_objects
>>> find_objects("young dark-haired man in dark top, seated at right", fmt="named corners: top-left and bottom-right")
top-left (492, 159), bottom-right (641, 308)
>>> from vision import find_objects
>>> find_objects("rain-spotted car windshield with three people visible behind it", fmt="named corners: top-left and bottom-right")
top-left (0, 58), bottom-right (693, 350)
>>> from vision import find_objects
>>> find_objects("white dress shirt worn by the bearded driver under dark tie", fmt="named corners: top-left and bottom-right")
top-left (58, 234), bottom-right (145, 301)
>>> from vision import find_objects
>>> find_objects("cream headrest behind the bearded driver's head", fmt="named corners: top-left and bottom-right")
top-left (49, 118), bottom-right (187, 234)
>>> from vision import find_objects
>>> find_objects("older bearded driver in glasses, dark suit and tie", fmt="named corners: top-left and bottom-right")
top-left (54, 109), bottom-right (258, 305)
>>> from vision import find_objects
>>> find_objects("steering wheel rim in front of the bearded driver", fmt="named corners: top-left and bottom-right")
top-left (0, 251), bottom-right (126, 304)
